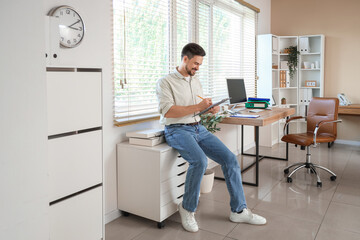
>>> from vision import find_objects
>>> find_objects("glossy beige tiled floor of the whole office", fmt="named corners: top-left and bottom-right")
top-left (105, 144), bottom-right (360, 240)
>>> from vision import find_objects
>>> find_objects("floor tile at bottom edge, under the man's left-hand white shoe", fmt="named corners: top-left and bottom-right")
top-left (134, 221), bottom-right (225, 240)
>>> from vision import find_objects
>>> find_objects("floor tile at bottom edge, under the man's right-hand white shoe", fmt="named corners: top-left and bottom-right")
top-left (228, 208), bottom-right (319, 240)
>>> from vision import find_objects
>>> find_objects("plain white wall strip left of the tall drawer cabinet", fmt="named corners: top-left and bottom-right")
top-left (0, 0), bottom-right (49, 240)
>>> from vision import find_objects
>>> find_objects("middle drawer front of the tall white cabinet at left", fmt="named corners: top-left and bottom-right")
top-left (48, 130), bottom-right (102, 202)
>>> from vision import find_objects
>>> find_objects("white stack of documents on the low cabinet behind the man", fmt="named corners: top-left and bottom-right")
top-left (126, 129), bottom-right (165, 147)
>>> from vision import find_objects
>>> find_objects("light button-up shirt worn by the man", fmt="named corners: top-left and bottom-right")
top-left (156, 69), bottom-right (204, 125)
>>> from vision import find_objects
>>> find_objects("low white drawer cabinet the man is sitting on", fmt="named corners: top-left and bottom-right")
top-left (117, 142), bottom-right (188, 227)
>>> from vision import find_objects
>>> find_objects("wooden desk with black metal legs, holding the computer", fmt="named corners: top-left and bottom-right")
top-left (221, 107), bottom-right (295, 186)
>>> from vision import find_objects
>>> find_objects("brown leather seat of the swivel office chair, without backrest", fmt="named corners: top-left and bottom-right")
top-left (281, 132), bottom-right (336, 146)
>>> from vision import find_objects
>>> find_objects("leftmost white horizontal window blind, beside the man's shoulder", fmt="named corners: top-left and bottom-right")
top-left (113, 0), bottom-right (169, 123)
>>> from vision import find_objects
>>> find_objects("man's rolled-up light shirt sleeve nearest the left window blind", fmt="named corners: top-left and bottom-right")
top-left (156, 78), bottom-right (175, 116)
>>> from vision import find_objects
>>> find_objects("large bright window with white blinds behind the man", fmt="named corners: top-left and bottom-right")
top-left (113, 0), bottom-right (257, 125)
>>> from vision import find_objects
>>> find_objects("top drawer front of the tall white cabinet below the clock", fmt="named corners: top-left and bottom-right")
top-left (46, 72), bottom-right (102, 135)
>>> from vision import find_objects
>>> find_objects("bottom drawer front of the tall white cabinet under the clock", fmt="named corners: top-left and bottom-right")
top-left (49, 187), bottom-right (103, 240)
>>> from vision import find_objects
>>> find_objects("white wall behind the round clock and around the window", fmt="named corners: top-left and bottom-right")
top-left (44, 0), bottom-right (270, 222)
